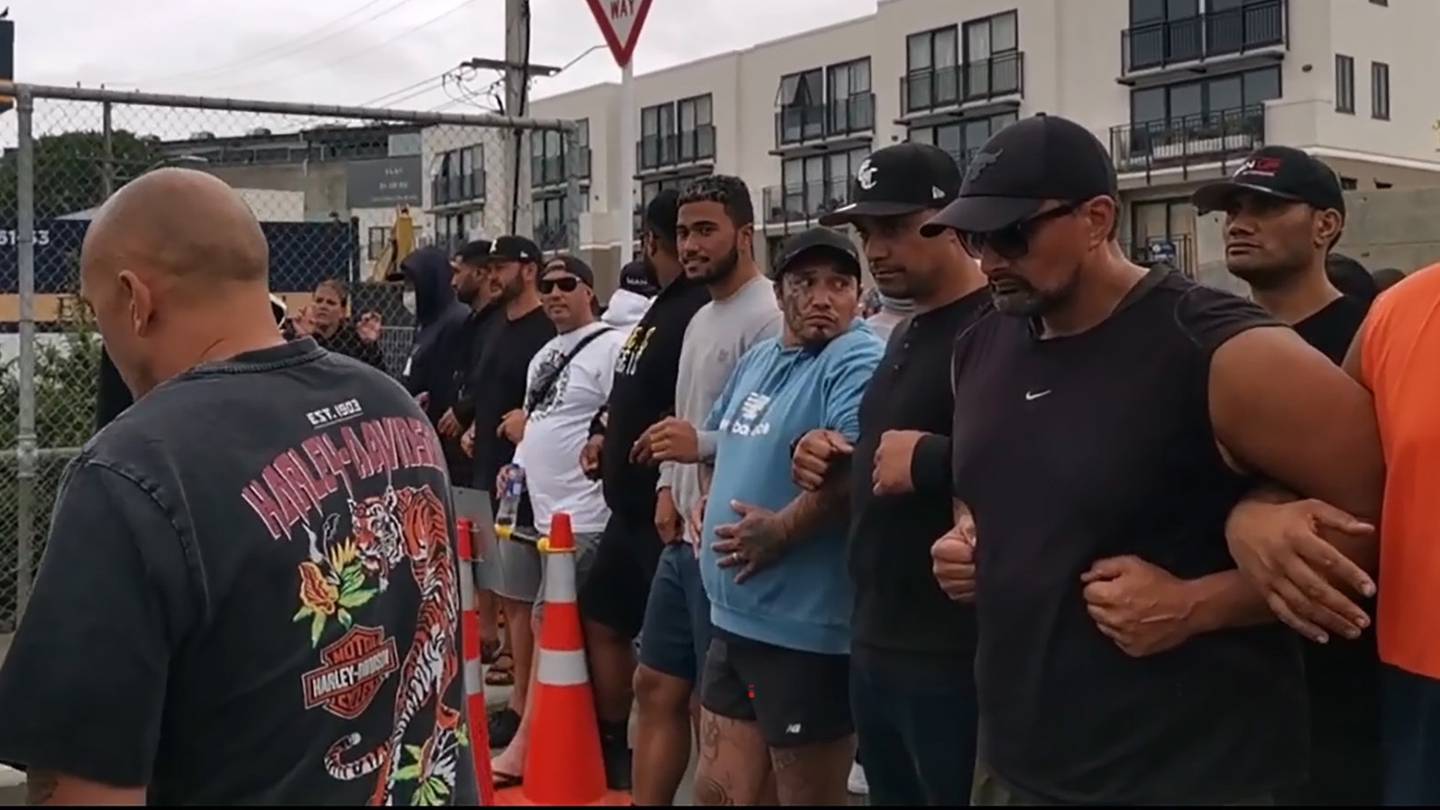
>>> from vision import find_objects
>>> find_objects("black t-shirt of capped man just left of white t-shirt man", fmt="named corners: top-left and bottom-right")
top-left (472, 307), bottom-right (552, 491)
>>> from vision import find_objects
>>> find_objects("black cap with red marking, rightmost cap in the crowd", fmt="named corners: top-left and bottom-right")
top-left (1191, 146), bottom-right (1345, 216)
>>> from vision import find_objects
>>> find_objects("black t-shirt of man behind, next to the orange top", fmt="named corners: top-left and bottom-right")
top-left (1284, 289), bottom-right (1382, 807)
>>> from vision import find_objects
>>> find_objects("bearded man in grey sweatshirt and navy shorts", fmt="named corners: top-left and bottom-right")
top-left (632, 174), bottom-right (780, 804)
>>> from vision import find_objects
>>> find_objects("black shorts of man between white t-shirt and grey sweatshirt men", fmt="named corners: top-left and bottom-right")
top-left (577, 515), bottom-right (664, 638)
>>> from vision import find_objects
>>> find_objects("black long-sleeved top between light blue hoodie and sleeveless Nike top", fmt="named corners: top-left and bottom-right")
top-left (850, 288), bottom-right (991, 657)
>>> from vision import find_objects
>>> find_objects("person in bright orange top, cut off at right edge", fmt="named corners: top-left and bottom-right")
top-left (1345, 259), bottom-right (1440, 806)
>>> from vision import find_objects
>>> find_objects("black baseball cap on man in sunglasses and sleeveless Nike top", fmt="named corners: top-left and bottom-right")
top-left (920, 112), bottom-right (1120, 236)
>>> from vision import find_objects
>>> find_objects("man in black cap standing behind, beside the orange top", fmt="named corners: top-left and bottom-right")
top-left (1192, 146), bottom-right (1382, 806)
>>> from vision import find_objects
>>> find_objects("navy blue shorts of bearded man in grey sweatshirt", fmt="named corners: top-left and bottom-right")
top-left (639, 542), bottom-right (711, 683)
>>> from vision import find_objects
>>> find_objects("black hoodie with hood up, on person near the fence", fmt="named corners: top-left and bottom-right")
top-left (400, 242), bottom-right (469, 481)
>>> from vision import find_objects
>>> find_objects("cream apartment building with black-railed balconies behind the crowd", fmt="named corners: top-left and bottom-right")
top-left (530, 0), bottom-right (1440, 285)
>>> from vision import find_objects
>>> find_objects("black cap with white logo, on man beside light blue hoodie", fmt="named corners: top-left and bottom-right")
top-left (819, 143), bottom-right (960, 228)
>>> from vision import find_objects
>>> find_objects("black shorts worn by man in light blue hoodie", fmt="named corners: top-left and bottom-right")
top-left (700, 627), bottom-right (855, 748)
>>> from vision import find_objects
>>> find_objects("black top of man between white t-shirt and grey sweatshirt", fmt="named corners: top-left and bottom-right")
top-left (600, 275), bottom-right (710, 526)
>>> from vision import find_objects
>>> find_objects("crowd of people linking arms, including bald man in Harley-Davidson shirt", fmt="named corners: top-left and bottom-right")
top-left (0, 115), bottom-right (1440, 806)
